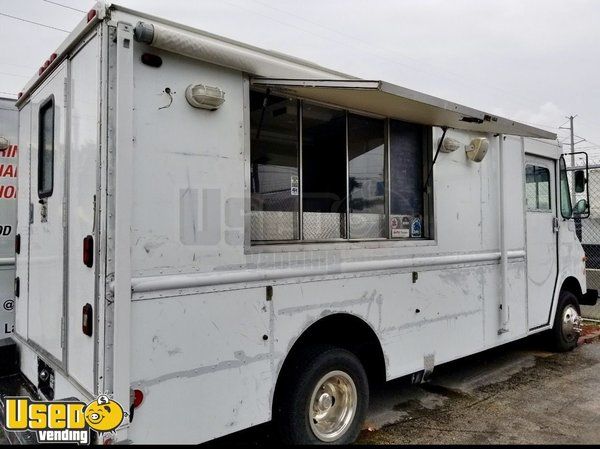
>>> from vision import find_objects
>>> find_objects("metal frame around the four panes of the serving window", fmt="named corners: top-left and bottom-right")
top-left (245, 86), bottom-right (437, 247)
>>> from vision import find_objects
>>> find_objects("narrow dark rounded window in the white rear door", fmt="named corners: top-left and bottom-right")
top-left (38, 97), bottom-right (54, 198)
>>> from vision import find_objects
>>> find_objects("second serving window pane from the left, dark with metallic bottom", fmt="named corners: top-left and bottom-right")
top-left (302, 103), bottom-right (346, 240)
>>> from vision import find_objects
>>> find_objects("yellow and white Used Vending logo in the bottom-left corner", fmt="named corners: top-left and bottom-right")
top-left (4, 395), bottom-right (126, 444)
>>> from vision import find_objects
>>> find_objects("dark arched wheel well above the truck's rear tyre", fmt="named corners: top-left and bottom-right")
top-left (276, 313), bottom-right (386, 391)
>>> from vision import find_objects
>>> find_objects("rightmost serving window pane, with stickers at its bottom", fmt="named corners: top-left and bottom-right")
top-left (390, 120), bottom-right (430, 238)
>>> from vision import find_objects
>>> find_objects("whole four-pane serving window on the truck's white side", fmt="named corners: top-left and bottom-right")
top-left (250, 89), bottom-right (432, 244)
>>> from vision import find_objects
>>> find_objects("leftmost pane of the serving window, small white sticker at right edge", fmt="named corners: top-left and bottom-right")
top-left (250, 91), bottom-right (300, 241)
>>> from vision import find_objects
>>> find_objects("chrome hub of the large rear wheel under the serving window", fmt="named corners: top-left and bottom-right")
top-left (309, 371), bottom-right (358, 442)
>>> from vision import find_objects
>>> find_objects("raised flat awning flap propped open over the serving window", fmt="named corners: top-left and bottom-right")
top-left (251, 78), bottom-right (556, 140)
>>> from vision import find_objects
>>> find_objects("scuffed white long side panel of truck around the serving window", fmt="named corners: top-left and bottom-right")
top-left (120, 19), bottom-right (527, 442)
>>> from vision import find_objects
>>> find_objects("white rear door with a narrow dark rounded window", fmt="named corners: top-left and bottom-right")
top-left (27, 60), bottom-right (68, 365)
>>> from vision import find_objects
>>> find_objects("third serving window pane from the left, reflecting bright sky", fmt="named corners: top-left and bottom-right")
top-left (348, 114), bottom-right (387, 239)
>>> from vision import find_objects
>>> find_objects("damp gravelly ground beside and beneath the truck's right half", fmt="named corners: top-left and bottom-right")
top-left (359, 334), bottom-right (600, 444)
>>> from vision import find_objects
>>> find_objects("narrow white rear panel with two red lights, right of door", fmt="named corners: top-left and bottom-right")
top-left (67, 30), bottom-right (100, 392)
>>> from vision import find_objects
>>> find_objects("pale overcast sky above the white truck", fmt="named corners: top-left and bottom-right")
top-left (0, 0), bottom-right (600, 156)
